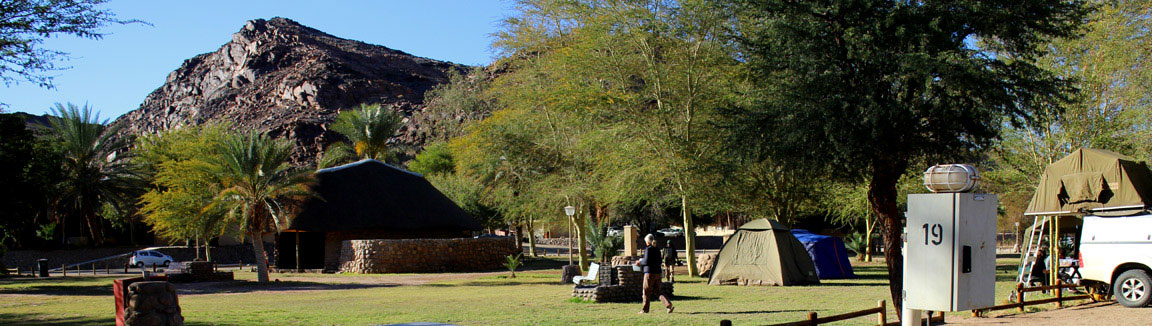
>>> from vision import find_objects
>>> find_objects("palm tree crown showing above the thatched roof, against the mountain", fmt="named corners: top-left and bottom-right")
top-left (319, 104), bottom-right (404, 168)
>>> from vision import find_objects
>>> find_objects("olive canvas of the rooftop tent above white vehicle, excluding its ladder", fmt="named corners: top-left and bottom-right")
top-left (1025, 149), bottom-right (1152, 215)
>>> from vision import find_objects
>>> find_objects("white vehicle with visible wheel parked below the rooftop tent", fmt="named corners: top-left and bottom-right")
top-left (1079, 214), bottom-right (1152, 308)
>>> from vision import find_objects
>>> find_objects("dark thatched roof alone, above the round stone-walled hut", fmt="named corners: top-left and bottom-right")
top-left (289, 160), bottom-right (480, 232)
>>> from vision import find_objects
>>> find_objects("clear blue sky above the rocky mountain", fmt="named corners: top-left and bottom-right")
top-left (0, 0), bottom-right (511, 119)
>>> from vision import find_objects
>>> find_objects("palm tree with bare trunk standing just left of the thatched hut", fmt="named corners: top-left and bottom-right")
top-left (211, 132), bottom-right (311, 283)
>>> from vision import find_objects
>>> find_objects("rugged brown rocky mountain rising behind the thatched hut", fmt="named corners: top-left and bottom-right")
top-left (114, 17), bottom-right (467, 165)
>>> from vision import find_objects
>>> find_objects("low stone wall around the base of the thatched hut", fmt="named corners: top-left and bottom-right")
top-left (340, 237), bottom-right (517, 273)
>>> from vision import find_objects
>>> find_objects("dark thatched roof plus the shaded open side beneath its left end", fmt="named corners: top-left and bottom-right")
top-left (276, 159), bottom-right (480, 270)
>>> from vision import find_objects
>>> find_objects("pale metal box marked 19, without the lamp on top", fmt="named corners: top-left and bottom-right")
top-left (904, 192), bottom-right (996, 311)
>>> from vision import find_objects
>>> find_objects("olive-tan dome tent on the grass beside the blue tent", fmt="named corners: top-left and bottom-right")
top-left (708, 219), bottom-right (820, 286)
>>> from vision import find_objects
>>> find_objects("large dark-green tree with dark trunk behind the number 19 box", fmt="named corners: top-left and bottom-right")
top-left (729, 0), bottom-right (1087, 309)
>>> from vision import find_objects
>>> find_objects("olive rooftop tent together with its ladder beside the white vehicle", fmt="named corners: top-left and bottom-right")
top-left (1017, 149), bottom-right (1152, 287)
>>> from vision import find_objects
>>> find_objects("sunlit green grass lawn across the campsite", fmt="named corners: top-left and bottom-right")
top-left (0, 259), bottom-right (1082, 325)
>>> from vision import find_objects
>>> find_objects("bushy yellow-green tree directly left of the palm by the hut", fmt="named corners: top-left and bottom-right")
top-left (136, 124), bottom-right (227, 260)
